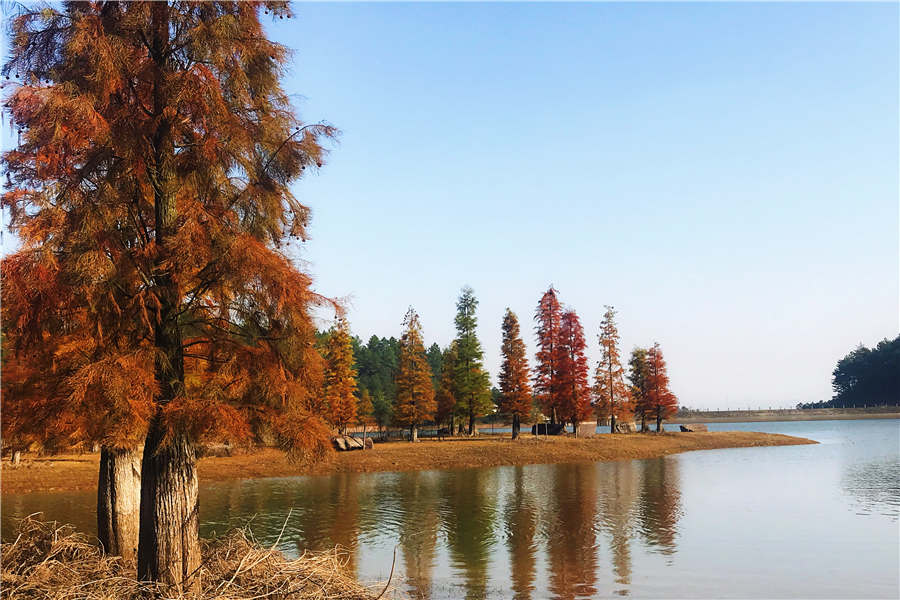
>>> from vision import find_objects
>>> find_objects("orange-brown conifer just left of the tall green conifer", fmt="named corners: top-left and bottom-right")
top-left (394, 307), bottom-right (435, 442)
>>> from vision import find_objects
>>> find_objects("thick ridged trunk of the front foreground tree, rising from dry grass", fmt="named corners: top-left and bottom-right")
top-left (138, 416), bottom-right (200, 591)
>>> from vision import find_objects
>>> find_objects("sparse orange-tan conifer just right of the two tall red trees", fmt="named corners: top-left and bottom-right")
top-left (594, 306), bottom-right (633, 433)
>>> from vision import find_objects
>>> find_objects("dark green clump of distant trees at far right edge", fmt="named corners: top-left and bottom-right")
top-left (797, 335), bottom-right (900, 408)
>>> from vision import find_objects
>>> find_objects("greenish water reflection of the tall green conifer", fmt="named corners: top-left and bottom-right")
top-left (440, 469), bottom-right (497, 598)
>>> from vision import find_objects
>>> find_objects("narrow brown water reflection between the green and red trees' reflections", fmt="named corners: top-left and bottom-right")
top-left (503, 467), bottom-right (537, 600)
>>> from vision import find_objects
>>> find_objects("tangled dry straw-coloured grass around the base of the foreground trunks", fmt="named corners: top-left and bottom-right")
top-left (0, 517), bottom-right (385, 600)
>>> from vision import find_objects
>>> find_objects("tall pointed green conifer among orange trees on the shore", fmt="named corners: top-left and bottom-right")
top-left (454, 286), bottom-right (493, 435)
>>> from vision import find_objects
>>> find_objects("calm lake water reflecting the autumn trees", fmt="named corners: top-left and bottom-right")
top-left (2, 420), bottom-right (900, 599)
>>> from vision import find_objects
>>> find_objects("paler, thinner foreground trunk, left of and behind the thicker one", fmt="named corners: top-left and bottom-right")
top-left (97, 446), bottom-right (141, 561)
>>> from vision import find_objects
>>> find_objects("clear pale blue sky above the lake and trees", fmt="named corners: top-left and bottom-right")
top-left (5, 3), bottom-right (900, 409)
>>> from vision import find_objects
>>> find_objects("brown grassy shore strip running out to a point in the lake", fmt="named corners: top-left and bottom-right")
top-left (0, 431), bottom-right (818, 495)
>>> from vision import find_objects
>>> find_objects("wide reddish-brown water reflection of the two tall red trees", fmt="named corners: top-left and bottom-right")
top-left (543, 463), bottom-right (597, 598)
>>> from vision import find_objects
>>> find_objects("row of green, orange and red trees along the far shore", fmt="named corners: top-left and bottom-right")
top-left (320, 286), bottom-right (677, 440)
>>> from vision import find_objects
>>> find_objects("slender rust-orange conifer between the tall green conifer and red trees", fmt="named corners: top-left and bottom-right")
top-left (499, 308), bottom-right (532, 439)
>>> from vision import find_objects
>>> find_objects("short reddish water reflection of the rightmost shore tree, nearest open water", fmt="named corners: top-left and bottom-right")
top-left (638, 458), bottom-right (681, 555)
